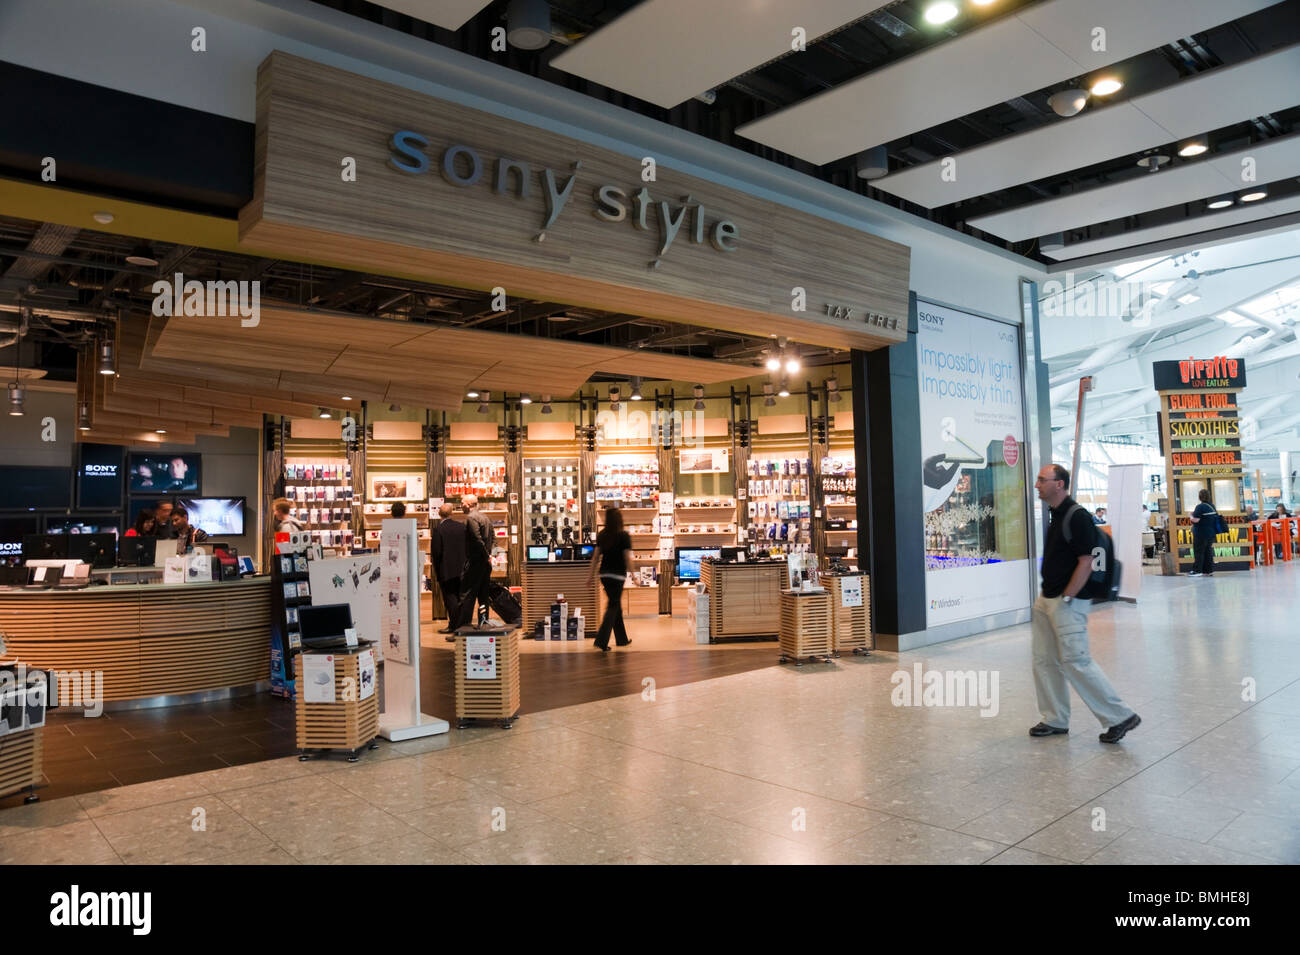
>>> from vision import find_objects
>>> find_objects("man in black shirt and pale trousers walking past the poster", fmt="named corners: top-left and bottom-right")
top-left (1030, 464), bottom-right (1141, 743)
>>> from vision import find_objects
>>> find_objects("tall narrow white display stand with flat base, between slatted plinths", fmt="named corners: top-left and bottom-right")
top-left (380, 517), bottom-right (451, 742)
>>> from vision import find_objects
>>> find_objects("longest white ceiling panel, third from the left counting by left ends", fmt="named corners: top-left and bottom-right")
top-left (736, 0), bottom-right (1271, 165)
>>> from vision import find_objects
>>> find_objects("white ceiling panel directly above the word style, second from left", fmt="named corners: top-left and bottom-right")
top-left (551, 0), bottom-right (889, 109)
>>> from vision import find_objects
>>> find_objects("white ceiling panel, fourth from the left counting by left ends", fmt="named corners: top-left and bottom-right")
top-left (872, 44), bottom-right (1300, 209)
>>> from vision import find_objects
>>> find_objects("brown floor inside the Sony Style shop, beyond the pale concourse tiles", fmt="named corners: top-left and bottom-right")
top-left (0, 617), bottom-right (777, 808)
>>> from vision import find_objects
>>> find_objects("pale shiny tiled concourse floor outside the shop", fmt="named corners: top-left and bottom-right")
top-left (0, 564), bottom-right (1300, 864)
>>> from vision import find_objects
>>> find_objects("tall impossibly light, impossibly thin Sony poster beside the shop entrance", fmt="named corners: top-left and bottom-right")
top-left (917, 301), bottom-right (1032, 626)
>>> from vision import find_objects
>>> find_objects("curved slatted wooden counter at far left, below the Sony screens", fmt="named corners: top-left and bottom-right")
top-left (0, 577), bottom-right (270, 703)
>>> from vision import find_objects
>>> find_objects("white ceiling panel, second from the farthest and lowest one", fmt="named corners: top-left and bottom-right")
top-left (970, 135), bottom-right (1300, 242)
